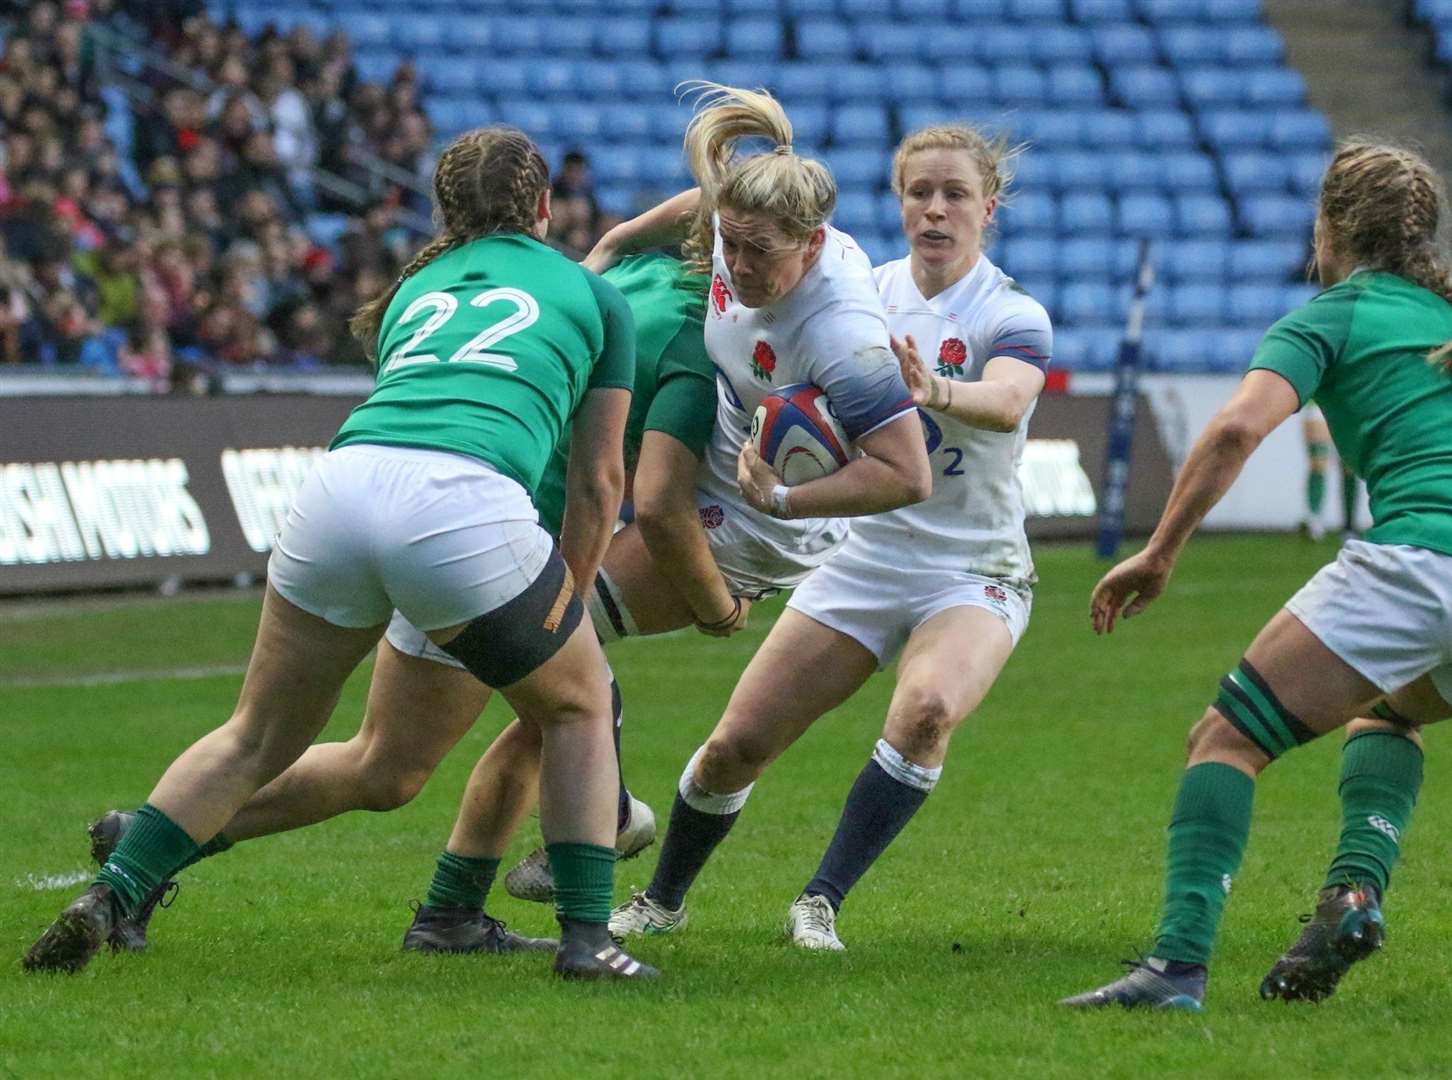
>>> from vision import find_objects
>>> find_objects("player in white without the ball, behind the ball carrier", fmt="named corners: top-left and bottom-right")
top-left (610, 126), bottom-right (1051, 949)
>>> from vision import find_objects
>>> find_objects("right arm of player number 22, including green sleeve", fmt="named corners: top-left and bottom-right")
top-left (559, 270), bottom-right (635, 589)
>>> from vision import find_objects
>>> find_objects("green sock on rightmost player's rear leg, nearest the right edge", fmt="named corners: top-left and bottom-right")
top-left (1326, 732), bottom-right (1422, 897)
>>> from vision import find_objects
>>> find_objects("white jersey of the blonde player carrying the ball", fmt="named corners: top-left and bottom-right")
top-left (697, 226), bottom-right (912, 544)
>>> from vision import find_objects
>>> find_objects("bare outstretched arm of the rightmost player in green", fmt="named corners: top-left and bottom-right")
top-left (1089, 370), bottom-right (1301, 634)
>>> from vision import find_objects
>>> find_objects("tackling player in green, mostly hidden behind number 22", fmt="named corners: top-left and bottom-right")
top-left (76, 254), bottom-right (751, 952)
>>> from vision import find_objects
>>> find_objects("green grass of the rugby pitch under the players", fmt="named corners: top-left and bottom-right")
top-left (0, 537), bottom-right (1452, 1079)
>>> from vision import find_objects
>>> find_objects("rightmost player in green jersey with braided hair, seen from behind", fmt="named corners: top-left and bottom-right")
top-left (1064, 141), bottom-right (1452, 1010)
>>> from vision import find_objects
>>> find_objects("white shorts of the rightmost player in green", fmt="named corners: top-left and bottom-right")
top-left (1285, 540), bottom-right (1452, 703)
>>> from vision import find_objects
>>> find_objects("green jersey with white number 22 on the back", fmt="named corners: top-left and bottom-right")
top-left (333, 232), bottom-right (635, 494)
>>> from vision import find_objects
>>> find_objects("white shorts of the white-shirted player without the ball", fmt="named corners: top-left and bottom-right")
top-left (787, 543), bottom-right (1034, 668)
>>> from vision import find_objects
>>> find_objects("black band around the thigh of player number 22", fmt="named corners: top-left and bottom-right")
top-left (443, 547), bottom-right (585, 687)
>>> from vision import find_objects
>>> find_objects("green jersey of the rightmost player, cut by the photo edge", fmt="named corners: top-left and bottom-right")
top-left (1250, 270), bottom-right (1452, 555)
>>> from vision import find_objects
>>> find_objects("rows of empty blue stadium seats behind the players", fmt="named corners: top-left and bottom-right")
top-left (201, 0), bottom-right (1330, 372)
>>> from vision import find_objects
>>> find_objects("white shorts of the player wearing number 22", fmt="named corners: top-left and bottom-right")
top-left (267, 444), bottom-right (555, 630)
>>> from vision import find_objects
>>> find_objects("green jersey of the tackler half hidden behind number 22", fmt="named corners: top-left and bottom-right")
top-left (534, 254), bottom-right (716, 536)
